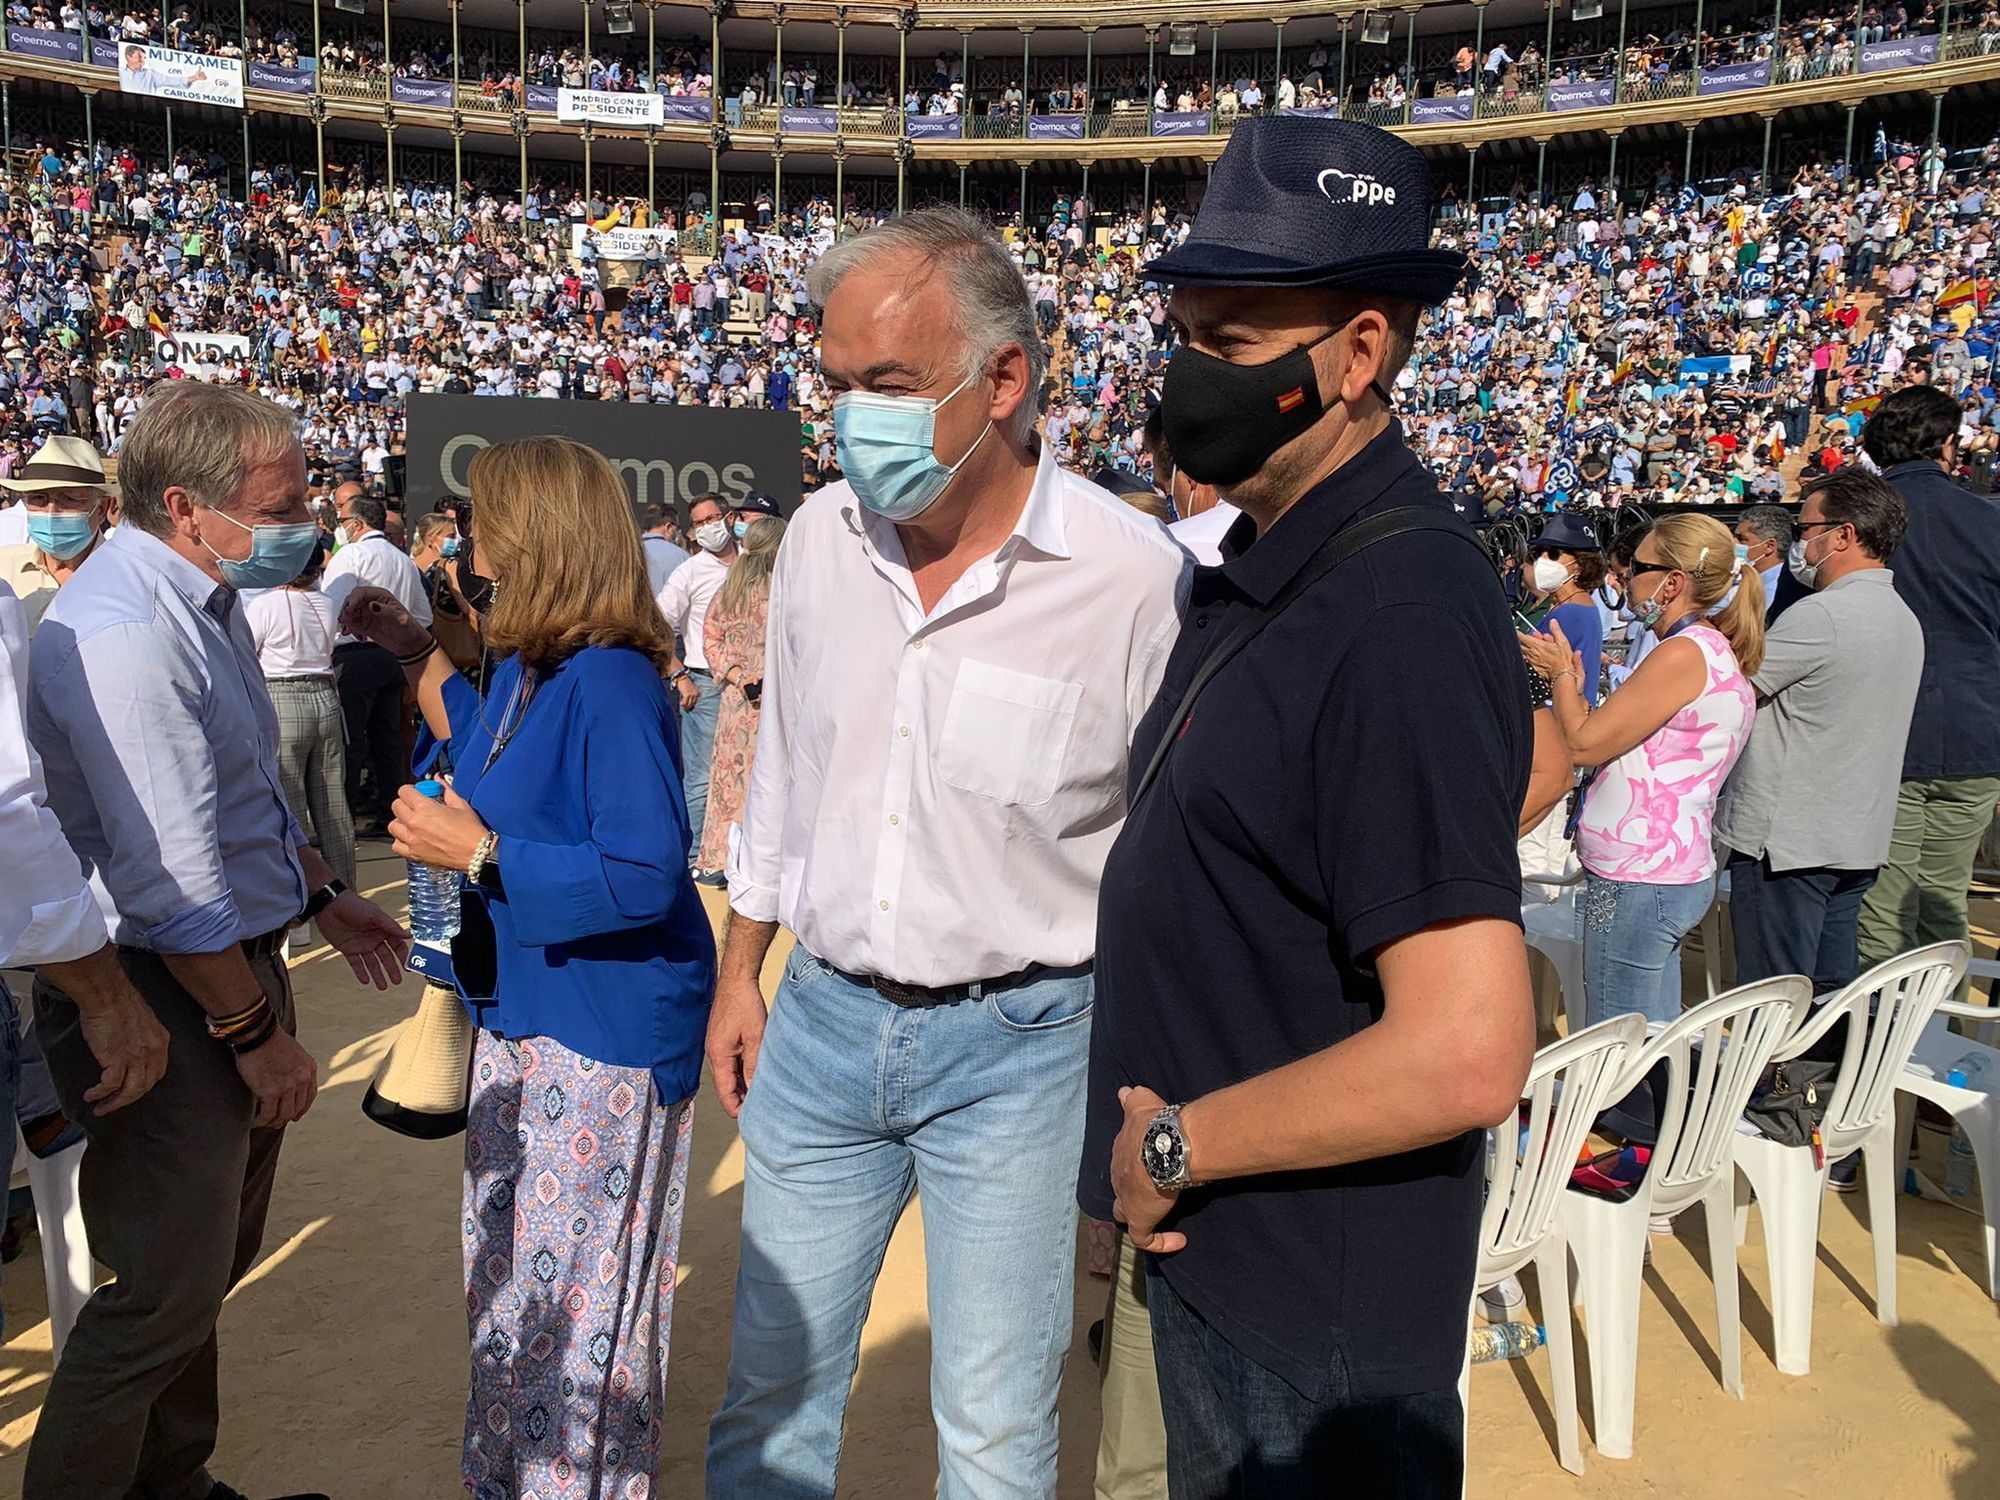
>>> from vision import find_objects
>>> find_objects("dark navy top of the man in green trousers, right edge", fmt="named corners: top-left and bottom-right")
top-left (1882, 458), bottom-right (2000, 780)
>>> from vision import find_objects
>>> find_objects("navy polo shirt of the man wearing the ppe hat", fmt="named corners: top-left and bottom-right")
top-left (1078, 422), bottom-right (1532, 1398)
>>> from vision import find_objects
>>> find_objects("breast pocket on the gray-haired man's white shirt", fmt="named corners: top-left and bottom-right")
top-left (938, 660), bottom-right (1084, 806)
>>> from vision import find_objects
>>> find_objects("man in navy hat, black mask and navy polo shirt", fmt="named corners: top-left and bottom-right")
top-left (1078, 116), bottom-right (1534, 1500)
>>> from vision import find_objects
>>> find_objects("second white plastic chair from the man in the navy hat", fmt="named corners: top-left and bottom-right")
top-left (1562, 974), bottom-right (1812, 1458)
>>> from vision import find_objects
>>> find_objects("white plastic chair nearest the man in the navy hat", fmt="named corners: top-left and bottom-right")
top-left (1458, 1016), bottom-right (1646, 1474)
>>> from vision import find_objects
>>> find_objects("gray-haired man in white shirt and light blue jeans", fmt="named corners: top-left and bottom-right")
top-left (690, 208), bottom-right (1188, 1500)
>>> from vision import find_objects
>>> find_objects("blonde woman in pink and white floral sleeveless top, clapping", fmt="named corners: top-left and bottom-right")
top-left (1522, 516), bottom-right (1764, 1056)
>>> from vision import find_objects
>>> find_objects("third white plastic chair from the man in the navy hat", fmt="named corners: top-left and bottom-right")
top-left (1736, 942), bottom-right (1972, 1374)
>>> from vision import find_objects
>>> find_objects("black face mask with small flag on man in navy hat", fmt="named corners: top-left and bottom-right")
top-left (1160, 318), bottom-right (1388, 484)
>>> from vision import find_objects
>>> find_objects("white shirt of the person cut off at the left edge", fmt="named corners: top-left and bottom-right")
top-left (0, 582), bottom-right (106, 968)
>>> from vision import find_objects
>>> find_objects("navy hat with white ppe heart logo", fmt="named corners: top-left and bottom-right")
top-left (1144, 114), bottom-right (1466, 306)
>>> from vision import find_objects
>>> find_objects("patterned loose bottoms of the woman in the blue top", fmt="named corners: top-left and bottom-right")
top-left (464, 1032), bottom-right (694, 1500)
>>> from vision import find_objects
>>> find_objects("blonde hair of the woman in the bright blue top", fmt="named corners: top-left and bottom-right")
top-left (468, 438), bottom-right (674, 672)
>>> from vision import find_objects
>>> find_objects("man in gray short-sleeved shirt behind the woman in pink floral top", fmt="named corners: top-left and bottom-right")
top-left (1716, 476), bottom-right (1924, 994)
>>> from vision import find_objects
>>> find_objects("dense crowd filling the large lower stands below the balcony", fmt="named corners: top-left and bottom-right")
top-left (0, 116), bottom-right (2000, 516)
